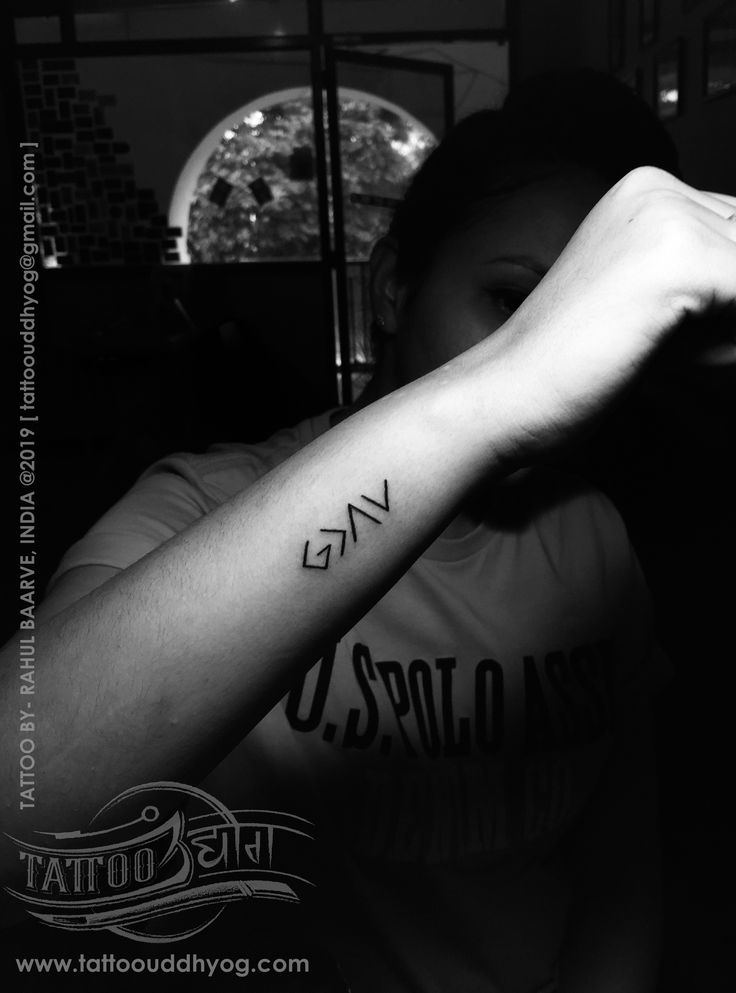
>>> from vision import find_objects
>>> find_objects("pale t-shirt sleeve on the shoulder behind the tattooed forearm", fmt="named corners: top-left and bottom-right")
top-left (49, 455), bottom-right (217, 587)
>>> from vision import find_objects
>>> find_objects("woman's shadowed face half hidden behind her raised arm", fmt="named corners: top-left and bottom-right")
top-left (396, 169), bottom-right (607, 385)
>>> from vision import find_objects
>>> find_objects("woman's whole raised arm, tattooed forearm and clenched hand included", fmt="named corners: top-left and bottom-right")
top-left (0, 169), bottom-right (736, 876)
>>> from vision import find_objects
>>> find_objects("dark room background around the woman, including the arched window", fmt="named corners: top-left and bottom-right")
top-left (2, 0), bottom-right (736, 993)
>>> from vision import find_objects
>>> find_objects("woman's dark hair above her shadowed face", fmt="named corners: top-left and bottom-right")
top-left (389, 69), bottom-right (679, 282)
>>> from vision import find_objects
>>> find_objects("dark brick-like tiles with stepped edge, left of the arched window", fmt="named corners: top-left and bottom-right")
top-left (20, 59), bottom-right (181, 266)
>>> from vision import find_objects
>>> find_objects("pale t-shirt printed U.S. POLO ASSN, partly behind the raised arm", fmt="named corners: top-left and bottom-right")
top-left (51, 413), bottom-right (664, 993)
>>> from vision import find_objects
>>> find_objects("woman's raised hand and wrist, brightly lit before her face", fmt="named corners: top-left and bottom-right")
top-left (478, 167), bottom-right (736, 461)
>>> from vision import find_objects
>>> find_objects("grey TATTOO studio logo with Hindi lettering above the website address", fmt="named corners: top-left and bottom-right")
top-left (6, 783), bottom-right (314, 942)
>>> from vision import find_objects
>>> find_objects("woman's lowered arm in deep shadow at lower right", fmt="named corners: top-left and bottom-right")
top-left (559, 711), bottom-right (661, 993)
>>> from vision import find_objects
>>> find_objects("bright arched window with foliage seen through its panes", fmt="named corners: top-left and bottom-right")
top-left (169, 88), bottom-right (436, 262)
